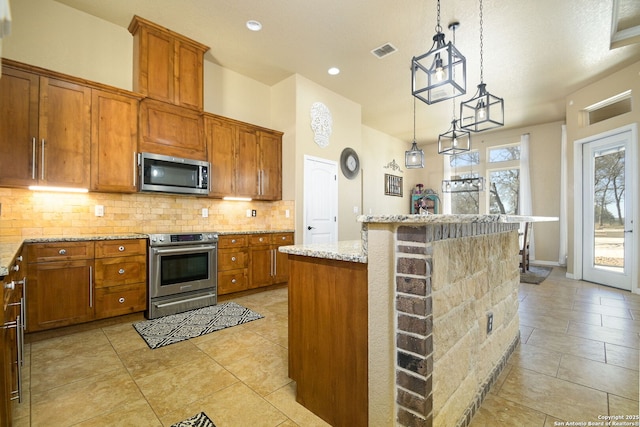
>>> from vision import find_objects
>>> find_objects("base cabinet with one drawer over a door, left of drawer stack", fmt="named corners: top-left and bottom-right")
top-left (26, 242), bottom-right (94, 332)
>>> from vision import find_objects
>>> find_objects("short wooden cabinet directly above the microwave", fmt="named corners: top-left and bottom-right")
top-left (138, 99), bottom-right (207, 161)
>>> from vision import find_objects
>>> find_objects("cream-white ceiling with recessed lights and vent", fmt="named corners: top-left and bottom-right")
top-left (57, 0), bottom-right (640, 144)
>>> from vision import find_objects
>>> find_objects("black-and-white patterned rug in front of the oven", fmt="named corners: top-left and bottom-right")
top-left (133, 302), bottom-right (263, 349)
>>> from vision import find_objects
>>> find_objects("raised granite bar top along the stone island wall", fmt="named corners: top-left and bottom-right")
top-left (358, 214), bottom-right (558, 224)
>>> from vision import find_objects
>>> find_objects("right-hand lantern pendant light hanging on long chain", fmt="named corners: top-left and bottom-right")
top-left (460, 0), bottom-right (504, 132)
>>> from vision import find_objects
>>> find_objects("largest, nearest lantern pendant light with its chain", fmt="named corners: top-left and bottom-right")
top-left (411, 0), bottom-right (467, 104)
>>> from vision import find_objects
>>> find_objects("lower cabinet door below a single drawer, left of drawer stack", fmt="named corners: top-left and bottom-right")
top-left (27, 260), bottom-right (93, 332)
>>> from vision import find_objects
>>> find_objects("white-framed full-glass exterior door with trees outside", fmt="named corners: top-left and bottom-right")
top-left (582, 130), bottom-right (637, 290)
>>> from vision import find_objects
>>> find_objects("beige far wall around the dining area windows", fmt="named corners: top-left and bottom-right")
top-left (421, 122), bottom-right (563, 265)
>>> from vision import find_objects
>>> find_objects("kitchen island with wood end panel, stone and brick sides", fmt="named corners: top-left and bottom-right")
top-left (280, 215), bottom-right (557, 426)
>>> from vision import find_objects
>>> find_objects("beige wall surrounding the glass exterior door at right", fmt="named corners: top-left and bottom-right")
top-left (566, 62), bottom-right (640, 292)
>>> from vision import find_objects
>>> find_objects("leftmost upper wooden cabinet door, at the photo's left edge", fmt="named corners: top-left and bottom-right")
top-left (0, 67), bottom-right (39, 186)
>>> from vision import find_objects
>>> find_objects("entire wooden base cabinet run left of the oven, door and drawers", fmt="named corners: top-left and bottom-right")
top-left (25, 239), bottom-right (147, 332)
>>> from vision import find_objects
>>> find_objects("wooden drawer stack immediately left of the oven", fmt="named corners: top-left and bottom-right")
top-left (95, 239), bottom-right (147, 319)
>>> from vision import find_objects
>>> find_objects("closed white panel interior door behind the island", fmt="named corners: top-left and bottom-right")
top-left (303, 156), bottom-right (338, 244)
